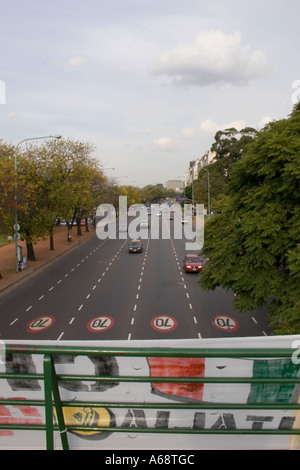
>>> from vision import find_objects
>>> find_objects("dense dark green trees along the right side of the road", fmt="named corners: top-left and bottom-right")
top-left (194, 103), bottom-right (300, 334)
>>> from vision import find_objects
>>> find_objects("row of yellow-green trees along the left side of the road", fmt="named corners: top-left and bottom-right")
top-left (0, 139), bottom-right (178, 278)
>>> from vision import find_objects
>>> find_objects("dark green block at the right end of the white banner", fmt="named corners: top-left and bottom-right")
top-left (247, 359), bottom-right (299, 403)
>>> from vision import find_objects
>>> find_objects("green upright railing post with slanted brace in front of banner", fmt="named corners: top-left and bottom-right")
top-left (44, 355), bottom-right (69, 450)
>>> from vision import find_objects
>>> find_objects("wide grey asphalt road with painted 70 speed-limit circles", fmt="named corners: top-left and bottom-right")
top-left (0, 216), bottom-right (270, 340)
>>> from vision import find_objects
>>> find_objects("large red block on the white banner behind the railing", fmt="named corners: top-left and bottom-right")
top-left (148, 357), bottom-right (205, 401)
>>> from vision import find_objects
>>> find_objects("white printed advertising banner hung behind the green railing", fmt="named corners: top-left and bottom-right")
top-left (0, 336), bottom-right (300, 450)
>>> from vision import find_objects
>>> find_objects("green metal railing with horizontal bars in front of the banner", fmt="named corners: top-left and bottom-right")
top-left (0, 344), bottom-right (300, 449)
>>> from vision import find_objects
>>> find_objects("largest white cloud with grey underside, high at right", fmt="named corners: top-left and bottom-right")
top-left (151, 30), bottom-right (270, 86)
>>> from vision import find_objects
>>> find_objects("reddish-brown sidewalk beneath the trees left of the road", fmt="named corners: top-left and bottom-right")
top-left (0, 227), bottom-right (95, 292)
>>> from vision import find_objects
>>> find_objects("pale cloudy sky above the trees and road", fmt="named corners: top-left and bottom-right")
top-left (0, 0), bottom-right (300, 186)
